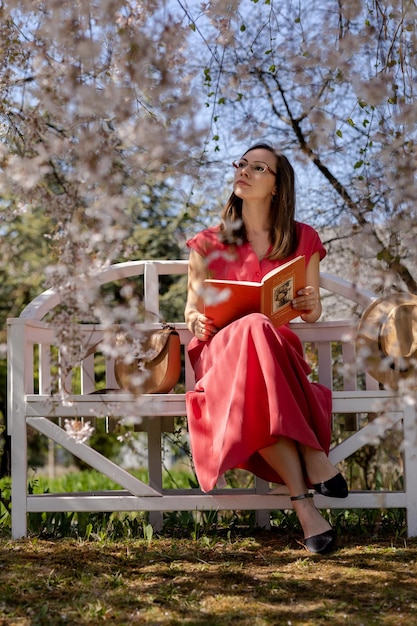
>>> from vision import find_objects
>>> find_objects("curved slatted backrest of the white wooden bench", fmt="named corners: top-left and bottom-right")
top-left (9, 260), bottom-right (378, 395)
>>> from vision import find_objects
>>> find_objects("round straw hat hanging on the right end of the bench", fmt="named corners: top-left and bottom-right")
top-left (357, 293), bottom-right (417, 389)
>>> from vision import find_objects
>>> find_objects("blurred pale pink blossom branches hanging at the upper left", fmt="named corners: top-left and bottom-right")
top-left (0, 0), bottom-right (213, 472)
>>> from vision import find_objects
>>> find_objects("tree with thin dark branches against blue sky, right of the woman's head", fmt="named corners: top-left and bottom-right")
top-left (188, 0), bottom-right (417, 292)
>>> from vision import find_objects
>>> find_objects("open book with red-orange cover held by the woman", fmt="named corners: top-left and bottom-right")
top-left (204, 256), bottom-right (306, 328)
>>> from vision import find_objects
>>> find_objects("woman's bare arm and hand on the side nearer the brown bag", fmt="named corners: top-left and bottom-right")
top-left (184, 250), bottom-right (217, 341)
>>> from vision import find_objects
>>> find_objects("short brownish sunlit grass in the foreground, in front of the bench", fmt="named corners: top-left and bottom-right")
top-left (0, 529), bottom-right (417, 626)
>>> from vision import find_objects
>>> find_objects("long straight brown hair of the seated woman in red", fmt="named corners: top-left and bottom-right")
top-left (220, 143), bottom-right (297, 259)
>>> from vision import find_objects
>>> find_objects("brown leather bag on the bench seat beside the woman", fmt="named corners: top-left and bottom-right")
top-left (114, 325), bottom-right (181, 394)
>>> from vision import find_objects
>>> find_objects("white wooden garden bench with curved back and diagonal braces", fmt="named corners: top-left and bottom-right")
top-left (8, 261), bottom-right (417, 538)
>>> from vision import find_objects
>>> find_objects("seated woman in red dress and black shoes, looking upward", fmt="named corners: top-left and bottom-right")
top-left (185, 144), bottom-right (348, 553)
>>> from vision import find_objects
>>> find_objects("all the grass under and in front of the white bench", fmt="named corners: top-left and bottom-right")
top-left (0, 472), bottom-right (417, 626)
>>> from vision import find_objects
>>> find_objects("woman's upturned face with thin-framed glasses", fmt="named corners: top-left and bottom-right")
top-left (233, 148), bottom-right (277, 200)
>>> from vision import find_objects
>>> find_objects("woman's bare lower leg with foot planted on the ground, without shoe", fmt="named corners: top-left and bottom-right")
top-left (259, 437), bottom-right (331, 539)
